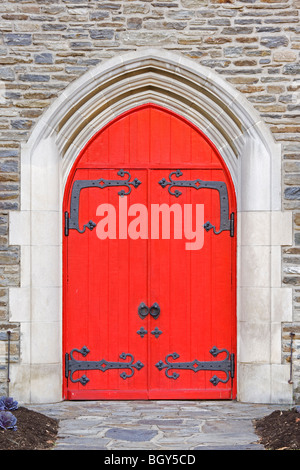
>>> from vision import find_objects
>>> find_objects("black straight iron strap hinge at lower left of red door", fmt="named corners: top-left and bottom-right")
top-left (65, 346), bottom-right (144, 385)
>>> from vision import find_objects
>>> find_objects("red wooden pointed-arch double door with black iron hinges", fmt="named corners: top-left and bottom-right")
top-left (63, 104), bottom-right (236, 399)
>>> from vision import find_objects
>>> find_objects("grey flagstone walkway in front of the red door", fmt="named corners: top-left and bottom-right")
top-left (28, 401), bottom-right (288, 451)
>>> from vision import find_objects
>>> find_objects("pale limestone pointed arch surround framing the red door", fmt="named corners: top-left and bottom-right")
top-left (9, 49), bottom-right (292, 403)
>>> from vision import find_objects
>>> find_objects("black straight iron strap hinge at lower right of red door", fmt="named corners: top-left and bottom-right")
top-left (155, 346), bottom-right (234, 386)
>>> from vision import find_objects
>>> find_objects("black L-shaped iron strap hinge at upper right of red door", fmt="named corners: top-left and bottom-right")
top-left (158, 170), bottom-right (234, 237)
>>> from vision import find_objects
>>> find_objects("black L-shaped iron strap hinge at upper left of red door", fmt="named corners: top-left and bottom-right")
top-left (65, 170), bottom-right (141, 236)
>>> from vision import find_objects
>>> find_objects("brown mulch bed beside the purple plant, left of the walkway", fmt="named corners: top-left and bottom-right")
top-left (0, 406), bottom-right (58, 450)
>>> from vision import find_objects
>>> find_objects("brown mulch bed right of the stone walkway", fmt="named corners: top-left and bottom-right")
top-left (254, 407), bottom-right (300, 450)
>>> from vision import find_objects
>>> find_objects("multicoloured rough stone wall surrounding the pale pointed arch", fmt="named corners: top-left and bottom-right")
top-left (0, 0), bottom-right (300, 401)
